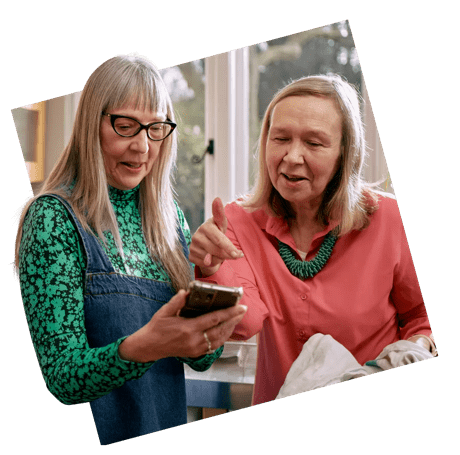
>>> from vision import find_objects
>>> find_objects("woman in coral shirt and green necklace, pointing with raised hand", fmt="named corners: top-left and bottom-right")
top-left (189, 76), bottom-right (435, 404)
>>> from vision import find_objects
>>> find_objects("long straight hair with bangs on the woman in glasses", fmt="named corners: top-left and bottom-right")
top-left (15, 53), bottom-right (190, 290)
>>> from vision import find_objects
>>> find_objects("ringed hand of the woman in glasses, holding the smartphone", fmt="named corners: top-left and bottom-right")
top-left (118, 290), bottom-right (247, 363)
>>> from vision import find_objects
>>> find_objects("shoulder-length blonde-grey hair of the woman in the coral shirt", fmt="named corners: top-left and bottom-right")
top-left (242, 74), bottom-right (377, 235)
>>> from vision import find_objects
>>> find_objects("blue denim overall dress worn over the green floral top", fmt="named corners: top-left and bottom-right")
top-left (53, 195), bottom-right (188, 445)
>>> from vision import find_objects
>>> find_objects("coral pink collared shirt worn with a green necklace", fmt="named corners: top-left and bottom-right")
top-left (197, 198), bottom-right (431, 404)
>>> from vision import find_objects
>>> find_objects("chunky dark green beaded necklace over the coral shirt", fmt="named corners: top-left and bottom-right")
top-left (278, 232), bottom-right (337, 280)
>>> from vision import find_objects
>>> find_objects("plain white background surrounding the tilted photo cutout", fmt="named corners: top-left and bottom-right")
top-left (0, 0), bottom-right (459, 455)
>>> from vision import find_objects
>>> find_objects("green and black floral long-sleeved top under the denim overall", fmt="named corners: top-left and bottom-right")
top-left (19, 187), bottom-right (223, 404)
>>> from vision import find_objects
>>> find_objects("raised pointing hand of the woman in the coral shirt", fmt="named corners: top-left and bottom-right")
top-left (189, 198), bottom-right (243, 277)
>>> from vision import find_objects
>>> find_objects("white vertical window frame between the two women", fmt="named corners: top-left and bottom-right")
top-left (204, 47), bottom-right (249, 219)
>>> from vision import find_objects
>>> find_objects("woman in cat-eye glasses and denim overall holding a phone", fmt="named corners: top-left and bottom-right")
top-left (15, 54), bottom-right (246, 444)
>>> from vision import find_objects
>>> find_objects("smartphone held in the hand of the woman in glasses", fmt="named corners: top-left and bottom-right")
top-left (179, 281), bottom-right (243, 318)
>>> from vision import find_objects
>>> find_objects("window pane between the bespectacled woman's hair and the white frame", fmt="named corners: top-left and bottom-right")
top-left (160, 59), bottom-right (205, 234)
